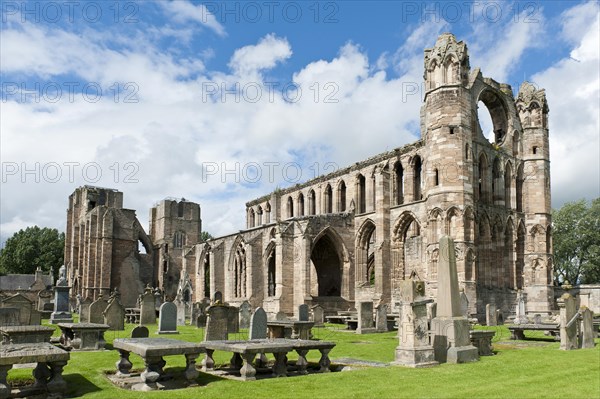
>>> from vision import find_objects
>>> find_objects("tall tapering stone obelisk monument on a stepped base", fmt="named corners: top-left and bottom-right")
top-left (431, 236), bottom-right (479, 363)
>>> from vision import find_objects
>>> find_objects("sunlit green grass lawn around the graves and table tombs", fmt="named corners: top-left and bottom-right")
top-left (8, 325), bottom-right (600, 399)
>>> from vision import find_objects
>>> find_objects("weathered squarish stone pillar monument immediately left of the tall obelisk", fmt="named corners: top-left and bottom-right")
top-left (393, 279), bottom-right (439, 367)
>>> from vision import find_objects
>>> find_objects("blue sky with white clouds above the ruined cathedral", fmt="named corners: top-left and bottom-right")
top-left (0, 0), bottom-right (600, 240)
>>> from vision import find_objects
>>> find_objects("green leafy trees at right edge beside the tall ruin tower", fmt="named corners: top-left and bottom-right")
top-left (552, 198), bottom-right (600, 285)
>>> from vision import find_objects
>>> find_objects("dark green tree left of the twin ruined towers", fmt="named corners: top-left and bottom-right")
top-left (0, 226), bottom-right (65, 277)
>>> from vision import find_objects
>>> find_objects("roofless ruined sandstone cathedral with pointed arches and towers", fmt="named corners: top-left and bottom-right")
top-left (65, 33), bottom-right (554, 317)
